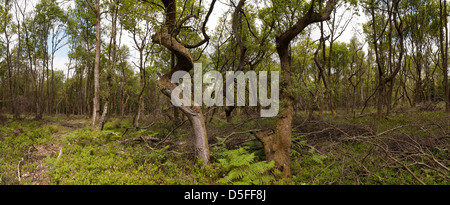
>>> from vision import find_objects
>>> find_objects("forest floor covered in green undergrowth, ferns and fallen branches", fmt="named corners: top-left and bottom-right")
top-left (0, 106), bottom-right (450, 184)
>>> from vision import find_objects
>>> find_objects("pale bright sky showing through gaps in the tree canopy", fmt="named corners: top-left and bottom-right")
top-left (45, 0), bottom-right (366, 75)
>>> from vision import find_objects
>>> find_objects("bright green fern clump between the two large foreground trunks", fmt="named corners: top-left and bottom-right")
top-left (218, 148), bottom-right (275, 185)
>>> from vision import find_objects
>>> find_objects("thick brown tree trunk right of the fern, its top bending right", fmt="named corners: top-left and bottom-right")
top-left (257, 0), bottom-right (336, 178)
